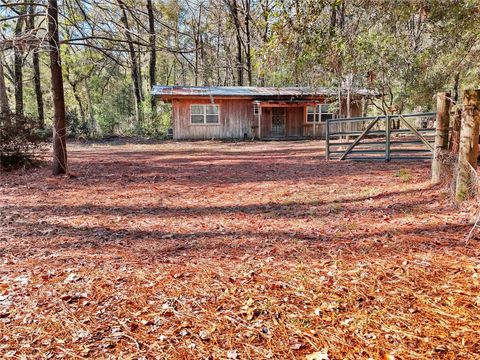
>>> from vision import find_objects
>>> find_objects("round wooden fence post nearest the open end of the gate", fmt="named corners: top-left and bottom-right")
top-left (432, 92), bottom-right (451, 184)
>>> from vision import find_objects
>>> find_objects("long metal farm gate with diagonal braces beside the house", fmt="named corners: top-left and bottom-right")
top-left (325, 113), bottom-right (436, 161)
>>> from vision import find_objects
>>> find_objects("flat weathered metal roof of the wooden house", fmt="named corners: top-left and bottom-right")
top-left (152, 85), bottom-right (378, 98)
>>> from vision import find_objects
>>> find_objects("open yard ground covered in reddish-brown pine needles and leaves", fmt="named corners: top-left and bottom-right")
top-left (0, 141), bottom-right (480, 360)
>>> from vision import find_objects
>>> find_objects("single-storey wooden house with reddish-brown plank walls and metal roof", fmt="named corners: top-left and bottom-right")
top-left (152, 86), bottom-right (376, 139)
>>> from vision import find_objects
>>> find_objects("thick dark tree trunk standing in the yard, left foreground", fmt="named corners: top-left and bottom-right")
top-left (47, 0), bottom-right (68, 175)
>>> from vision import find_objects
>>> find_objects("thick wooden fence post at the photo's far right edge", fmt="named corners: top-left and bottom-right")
top-left (455, 90), bottom-right (480, 202)
